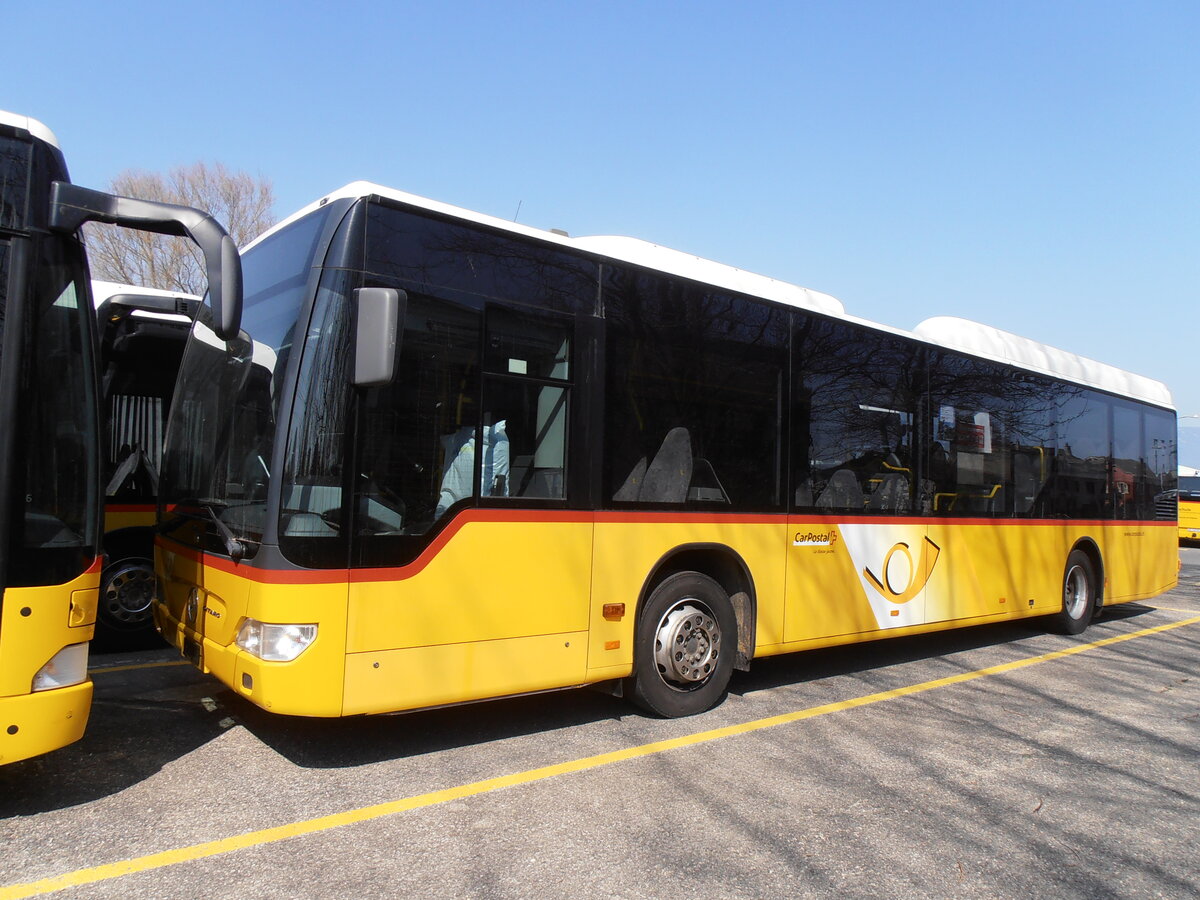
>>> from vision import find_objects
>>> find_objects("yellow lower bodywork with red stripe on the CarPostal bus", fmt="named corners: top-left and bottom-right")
top-left (156, 512), bottom-right (1177, 716)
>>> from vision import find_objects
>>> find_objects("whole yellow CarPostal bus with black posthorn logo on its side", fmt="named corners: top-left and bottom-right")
top-left (155, 182), bottom-right (1177, 716)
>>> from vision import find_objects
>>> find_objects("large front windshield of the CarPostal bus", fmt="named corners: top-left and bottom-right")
top-left (161, 205), bottom-right (326, 542)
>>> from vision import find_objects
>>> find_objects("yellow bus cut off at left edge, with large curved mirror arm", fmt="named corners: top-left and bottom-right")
top-left (0, 112), bottom-right (240, 764)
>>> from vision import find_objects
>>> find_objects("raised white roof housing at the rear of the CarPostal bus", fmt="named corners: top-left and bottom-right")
top-left (913, 316), bottom-right (1175, 409)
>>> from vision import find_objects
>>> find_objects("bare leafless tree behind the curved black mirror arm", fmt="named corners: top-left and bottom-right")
top-left (85, 162), bottom-right (275, 294)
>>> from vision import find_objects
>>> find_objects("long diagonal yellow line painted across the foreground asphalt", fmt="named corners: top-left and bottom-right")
top-left (0, 616), bottom-right (1200, 900)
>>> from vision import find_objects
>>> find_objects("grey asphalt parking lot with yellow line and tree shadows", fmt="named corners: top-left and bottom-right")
top-left (0, 548), bottom-right (1200, 900)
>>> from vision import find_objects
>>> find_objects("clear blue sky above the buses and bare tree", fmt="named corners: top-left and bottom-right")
top-left (11, 0), bottom-right (1200, 424)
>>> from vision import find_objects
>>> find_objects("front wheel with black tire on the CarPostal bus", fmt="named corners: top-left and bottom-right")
top-left (632, 572), bottom-right (738, 719)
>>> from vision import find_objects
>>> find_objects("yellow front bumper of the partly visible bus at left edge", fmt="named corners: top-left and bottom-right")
top-left (0, 680), bottom-right (92, 766)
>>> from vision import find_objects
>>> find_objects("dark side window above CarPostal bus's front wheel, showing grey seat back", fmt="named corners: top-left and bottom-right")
top-left (602, 266), bottom-right (790, 512)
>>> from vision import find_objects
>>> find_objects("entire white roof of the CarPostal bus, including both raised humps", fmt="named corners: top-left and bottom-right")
top-left (250, 181), bottom-right (1174, 408)
